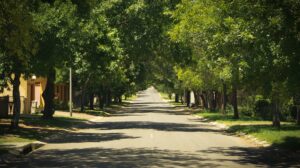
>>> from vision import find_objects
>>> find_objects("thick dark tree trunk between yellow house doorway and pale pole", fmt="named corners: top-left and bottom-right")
top-left (42, 68), bottom-right (55, 119)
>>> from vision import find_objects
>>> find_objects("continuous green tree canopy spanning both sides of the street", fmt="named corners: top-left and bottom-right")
top-left (0, 0), bottom-right (300, 125)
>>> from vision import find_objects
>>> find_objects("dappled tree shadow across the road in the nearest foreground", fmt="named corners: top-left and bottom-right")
top-left (7, 147), bottom-right (299, 168)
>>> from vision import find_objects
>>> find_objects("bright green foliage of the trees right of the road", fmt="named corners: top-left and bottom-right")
top-left (165, 0), bottom-right (300, 123)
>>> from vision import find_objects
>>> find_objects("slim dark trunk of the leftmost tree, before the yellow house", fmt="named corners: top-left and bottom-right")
top-left (11, 73), bottom-right (21, 128)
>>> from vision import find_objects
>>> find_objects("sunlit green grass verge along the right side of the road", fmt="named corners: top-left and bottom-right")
top-left (197, 112), bottom-right (300, 150)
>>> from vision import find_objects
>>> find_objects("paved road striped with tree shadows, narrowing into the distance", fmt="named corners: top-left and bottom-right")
top-left (5, 88), bottom-right (300, 167)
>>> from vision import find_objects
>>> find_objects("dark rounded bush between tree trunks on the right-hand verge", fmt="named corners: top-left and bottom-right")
top-left (254, 99), bottom-right (272, 120)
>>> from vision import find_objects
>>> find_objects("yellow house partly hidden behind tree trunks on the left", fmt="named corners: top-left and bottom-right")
top-left (0, 76), bottom-right (69, 114)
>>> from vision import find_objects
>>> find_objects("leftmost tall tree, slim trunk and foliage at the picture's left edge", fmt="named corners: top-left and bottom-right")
top-left (0, 0), bottom-right (37, 128)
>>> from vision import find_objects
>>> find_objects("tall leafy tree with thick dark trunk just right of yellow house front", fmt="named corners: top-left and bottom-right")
top-left (32, 0), bottom-right (77, 119)
